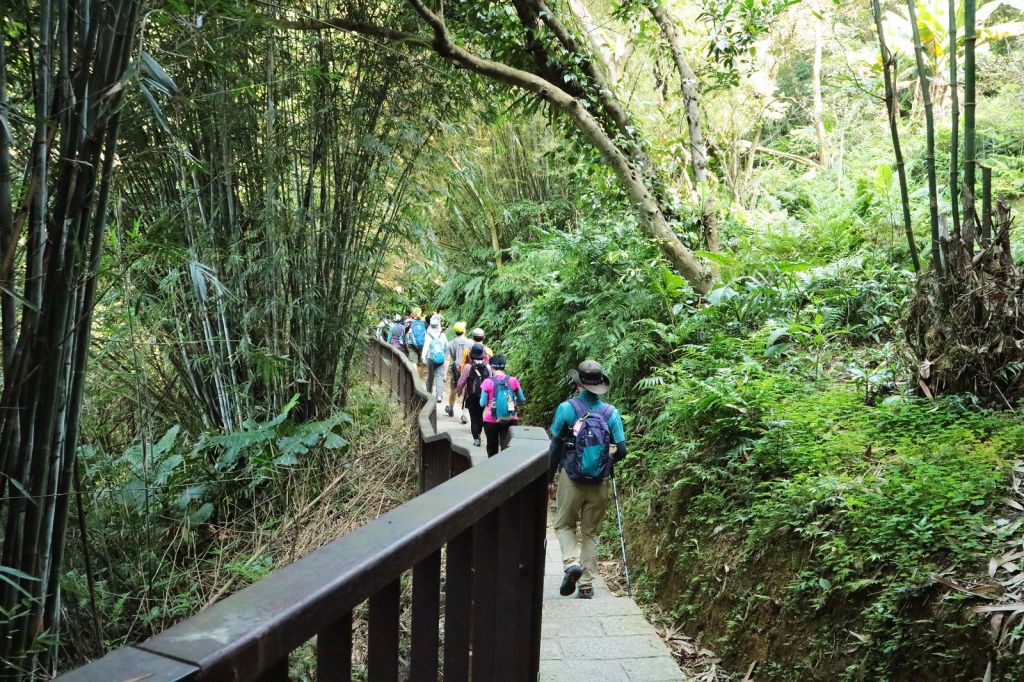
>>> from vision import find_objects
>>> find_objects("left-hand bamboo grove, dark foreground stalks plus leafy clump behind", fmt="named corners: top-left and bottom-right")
top-left (0, 0), bottom-right (458, 667)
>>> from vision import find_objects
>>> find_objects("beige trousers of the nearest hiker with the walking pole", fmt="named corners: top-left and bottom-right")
top-left (555, 469), bottom-right (611, 587)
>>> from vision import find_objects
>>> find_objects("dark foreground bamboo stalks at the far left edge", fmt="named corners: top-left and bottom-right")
top-left (0, 0), bottom-right (142, 677)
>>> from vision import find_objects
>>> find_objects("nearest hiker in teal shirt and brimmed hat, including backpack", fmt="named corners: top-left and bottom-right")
top-left (548, 360), bottom-right (626, 599)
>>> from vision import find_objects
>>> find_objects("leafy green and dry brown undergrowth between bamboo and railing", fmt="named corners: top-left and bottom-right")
top-left (61, 384), bottom-right (417, 679)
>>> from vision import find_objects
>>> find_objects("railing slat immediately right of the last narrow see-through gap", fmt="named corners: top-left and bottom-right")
top-left (444, 528), bottom-right (473, 680)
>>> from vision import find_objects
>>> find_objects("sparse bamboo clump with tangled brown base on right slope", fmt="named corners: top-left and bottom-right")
top-left (871, 0), bottom-right (1022, 403)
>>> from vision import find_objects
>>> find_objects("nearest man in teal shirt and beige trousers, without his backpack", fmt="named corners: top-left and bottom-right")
top-left (548, 360), bottom-right (626, 599)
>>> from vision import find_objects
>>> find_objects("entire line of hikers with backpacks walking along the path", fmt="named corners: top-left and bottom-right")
top-left (377, 308), bottom-right (629, 599)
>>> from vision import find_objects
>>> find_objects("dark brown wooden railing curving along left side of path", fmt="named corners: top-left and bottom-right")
top-left (59, 341), bottom-right (547, 682)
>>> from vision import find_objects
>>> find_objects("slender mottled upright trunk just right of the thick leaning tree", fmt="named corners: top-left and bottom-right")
top-left (649, 2), bottom-right (721, 252)
